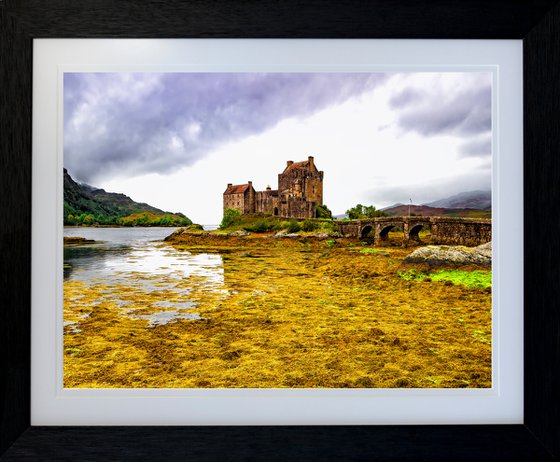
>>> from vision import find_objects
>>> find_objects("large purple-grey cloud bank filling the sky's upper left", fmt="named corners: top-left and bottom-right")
top-left (64, 73), bottom-right (388, 184)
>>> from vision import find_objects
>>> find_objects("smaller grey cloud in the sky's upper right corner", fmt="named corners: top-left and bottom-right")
top-left (396, 79), bottom-right (492, 137)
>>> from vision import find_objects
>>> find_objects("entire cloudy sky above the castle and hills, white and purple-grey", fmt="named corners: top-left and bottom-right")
top-left (64, 72), bottom-right (492, 224)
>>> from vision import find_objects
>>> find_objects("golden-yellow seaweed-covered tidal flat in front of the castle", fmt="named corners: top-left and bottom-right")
top-left (64, 235), bottom-right (492, 388)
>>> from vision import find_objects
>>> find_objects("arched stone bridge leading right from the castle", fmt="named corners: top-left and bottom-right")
top-left (336, 216), bottom-right (492, 246)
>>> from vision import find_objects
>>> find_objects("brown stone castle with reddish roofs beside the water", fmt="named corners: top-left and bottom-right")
top-left (224, 156), bottom-right (323, 218)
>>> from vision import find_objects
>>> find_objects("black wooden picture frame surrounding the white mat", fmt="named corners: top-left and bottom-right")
top-left (0, 0), bottom-right (560, 461)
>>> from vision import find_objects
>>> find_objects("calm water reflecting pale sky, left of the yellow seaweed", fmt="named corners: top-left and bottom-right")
top-left (64, 228), bottom-right (224, 332)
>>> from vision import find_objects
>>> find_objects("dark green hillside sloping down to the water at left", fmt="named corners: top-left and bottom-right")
top-left (64, 169), bottom-right (192, 226)
